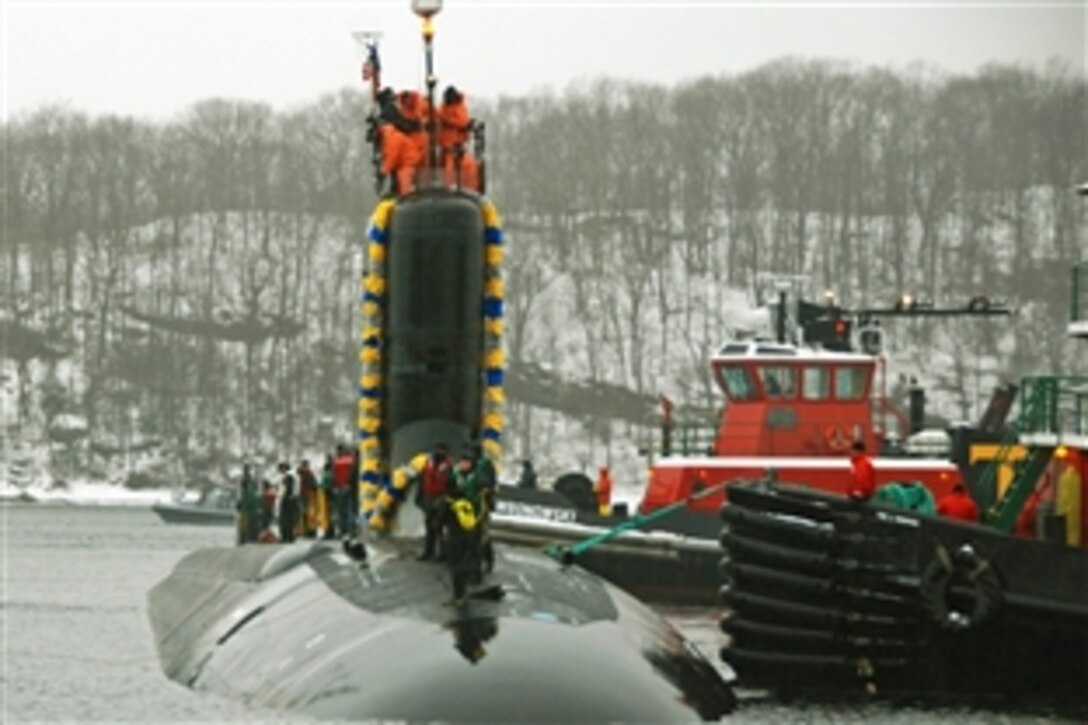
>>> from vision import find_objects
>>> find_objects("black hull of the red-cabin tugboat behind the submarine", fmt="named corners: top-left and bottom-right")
top-left (491, 487), bottom-right (721, 606)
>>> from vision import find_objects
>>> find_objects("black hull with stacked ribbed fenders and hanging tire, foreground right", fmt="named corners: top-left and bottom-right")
top-left (721, 484), bottom-right (1088, 704)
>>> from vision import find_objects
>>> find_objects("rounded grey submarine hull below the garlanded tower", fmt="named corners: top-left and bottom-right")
top-left (149, 543), bottom-right (735, 722)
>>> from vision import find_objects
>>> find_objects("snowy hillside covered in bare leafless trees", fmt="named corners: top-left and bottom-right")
top-left (0, 60), bottom-right (1088, 483)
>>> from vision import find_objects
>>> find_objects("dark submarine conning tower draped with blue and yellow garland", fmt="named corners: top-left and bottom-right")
top-left (358, 2), bottom-right (504, 533)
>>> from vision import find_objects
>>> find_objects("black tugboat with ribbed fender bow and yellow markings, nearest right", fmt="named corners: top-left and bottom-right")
top-left (721, 250), bottom-right (1088, 701)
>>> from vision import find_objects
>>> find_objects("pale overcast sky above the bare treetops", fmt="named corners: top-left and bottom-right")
top-left (0, 0), bottom-right (1088, 119)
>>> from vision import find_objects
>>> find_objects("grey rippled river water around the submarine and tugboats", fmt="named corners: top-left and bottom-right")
top-left (0, 504), bottom-right (1065, 724)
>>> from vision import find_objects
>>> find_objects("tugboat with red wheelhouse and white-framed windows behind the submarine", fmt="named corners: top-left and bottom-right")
top-left (492, 283), bottom-right (1009, 605)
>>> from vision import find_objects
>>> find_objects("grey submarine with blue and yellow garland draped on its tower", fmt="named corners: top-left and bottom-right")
top-left (148, 0), bottom-right (737, 722)
